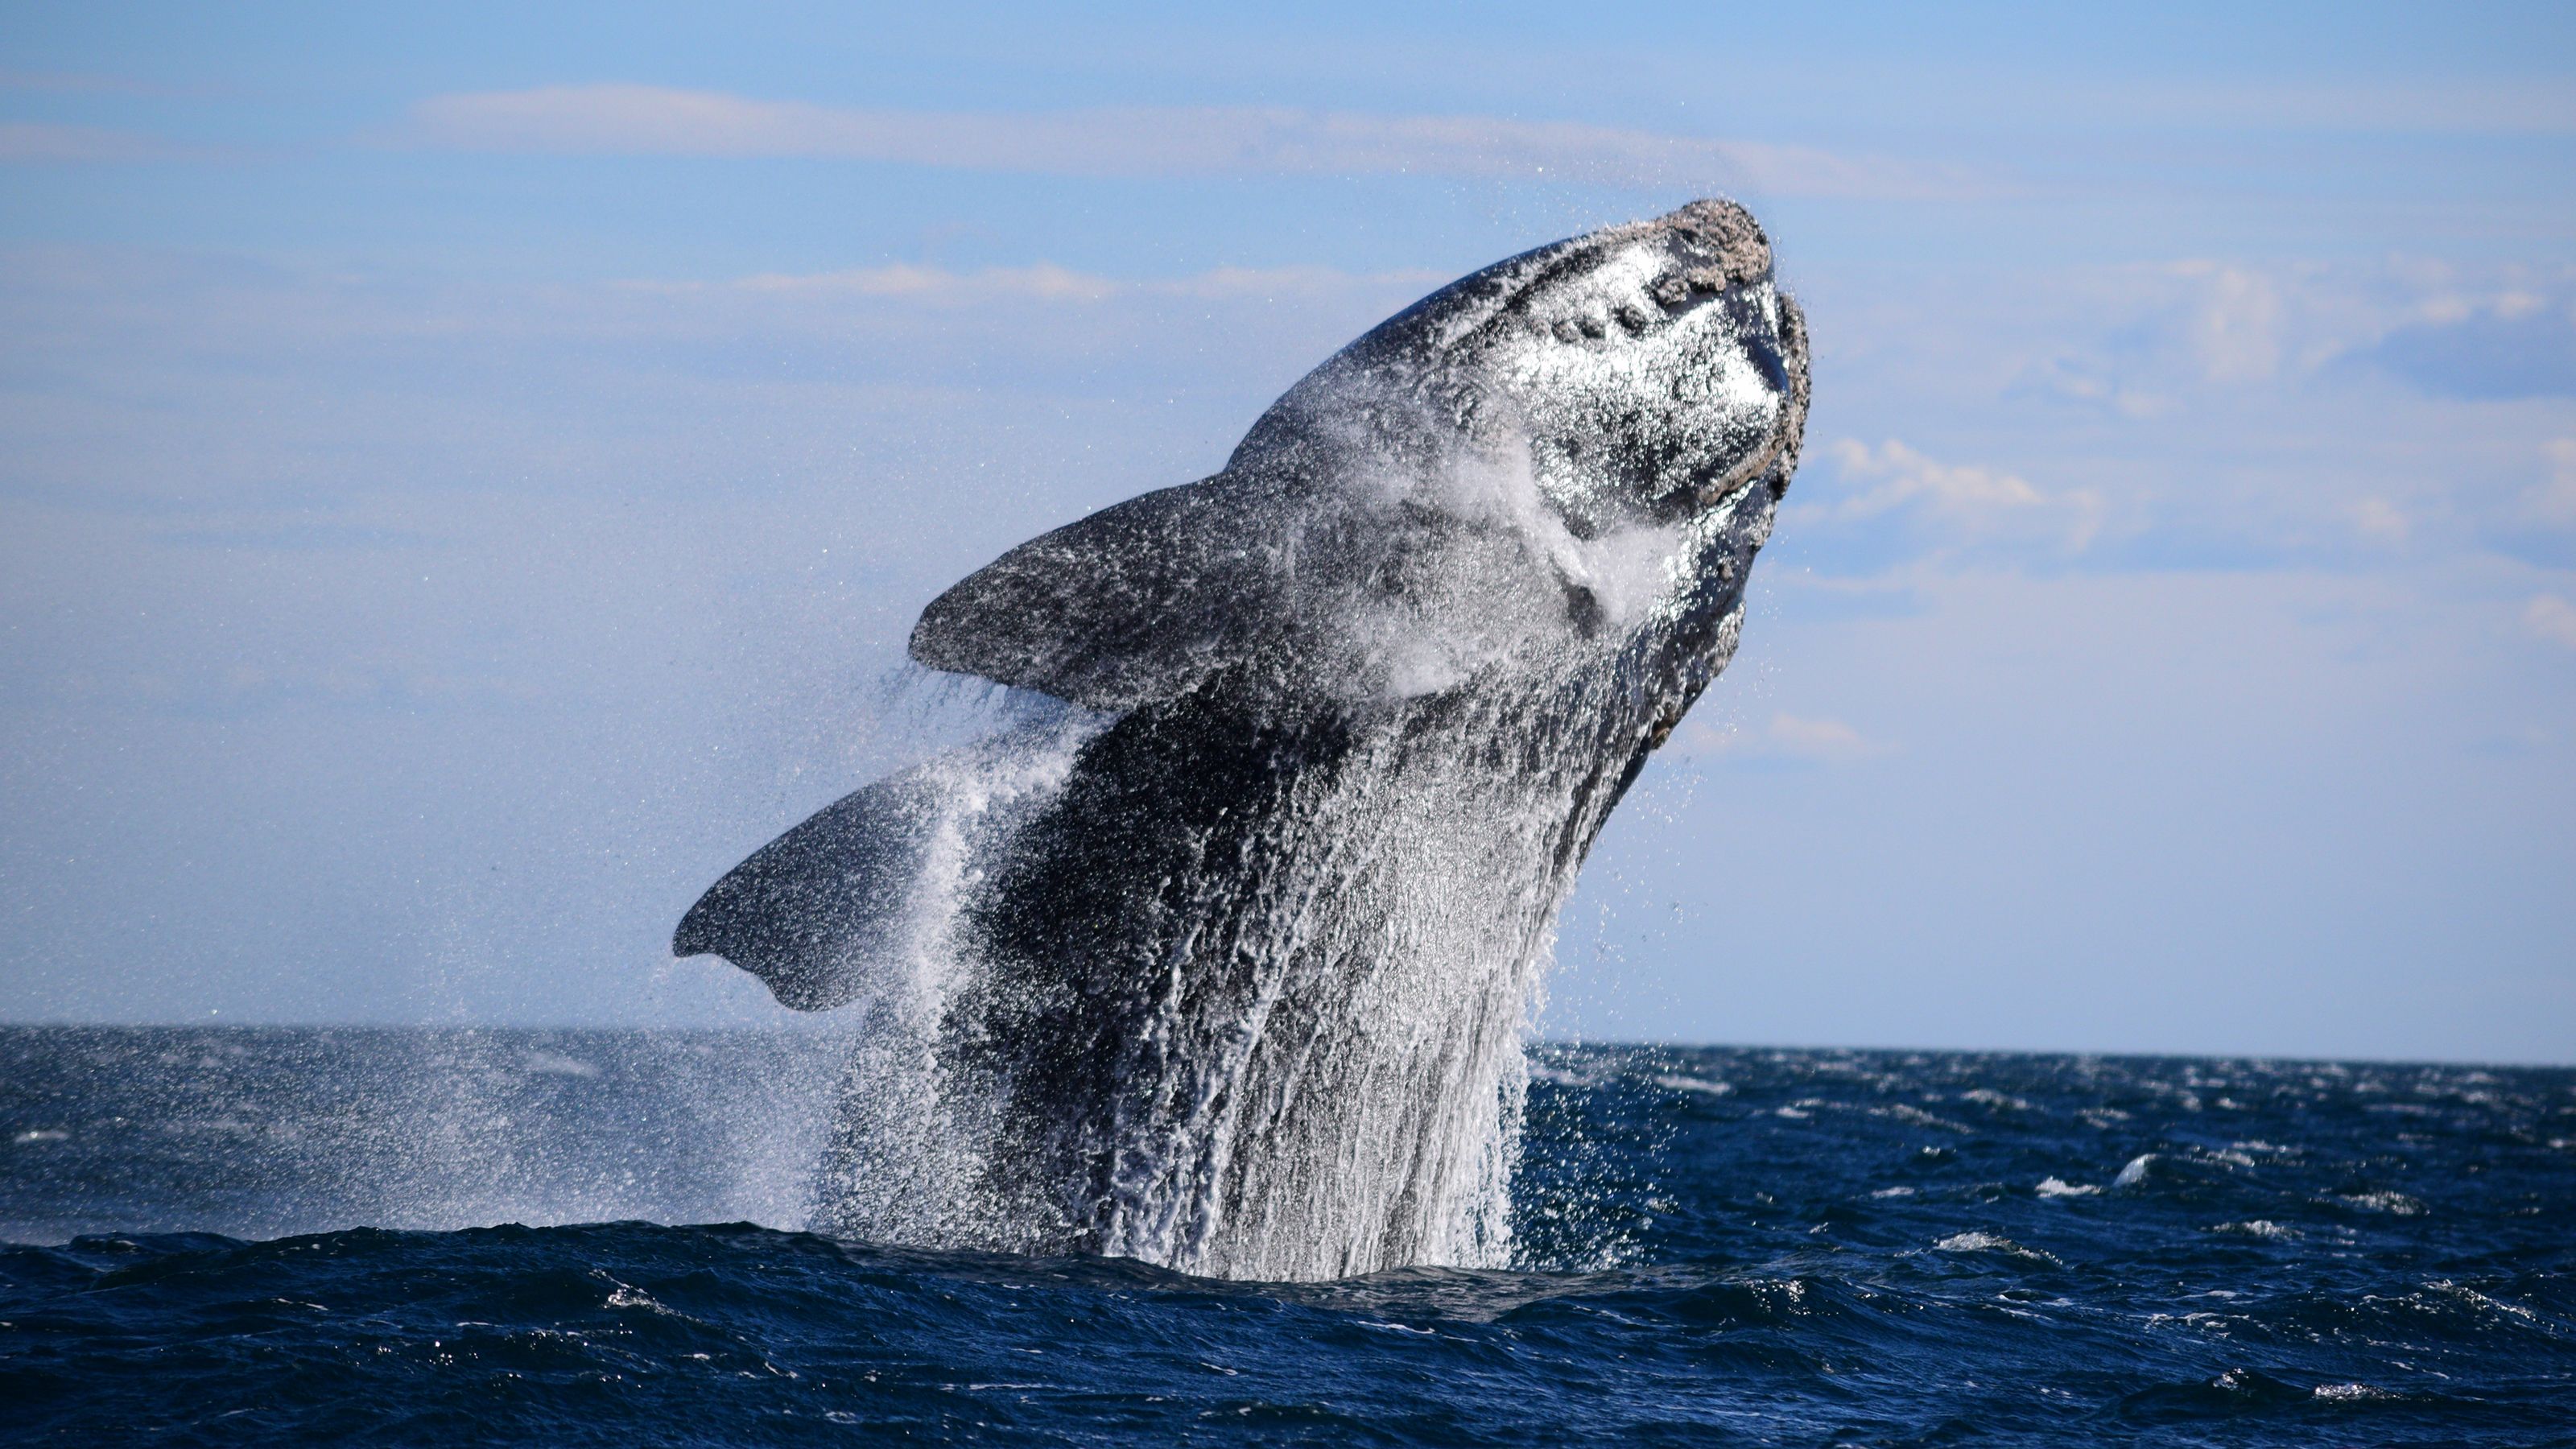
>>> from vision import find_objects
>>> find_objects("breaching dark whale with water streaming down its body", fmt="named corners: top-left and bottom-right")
top-left (672, 201), bottom-right (1808, 1279)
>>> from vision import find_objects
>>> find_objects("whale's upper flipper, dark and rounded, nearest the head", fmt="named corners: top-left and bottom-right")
top-left (912, 474), bottom-right (1290, 709)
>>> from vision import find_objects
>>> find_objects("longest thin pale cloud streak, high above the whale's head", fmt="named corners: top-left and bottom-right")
top-left (407, 85), bottom-right (1992, 199)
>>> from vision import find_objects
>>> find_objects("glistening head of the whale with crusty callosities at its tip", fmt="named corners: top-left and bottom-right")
top-left (1226, 201), bottom-right (1808, 536)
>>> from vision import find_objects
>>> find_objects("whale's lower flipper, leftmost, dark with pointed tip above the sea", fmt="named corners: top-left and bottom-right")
top-left (670, 774), bottom-right (932, 1011)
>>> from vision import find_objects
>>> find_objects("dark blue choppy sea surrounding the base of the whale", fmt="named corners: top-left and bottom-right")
top-left (0, 1029), bottom-right (2576, 1444)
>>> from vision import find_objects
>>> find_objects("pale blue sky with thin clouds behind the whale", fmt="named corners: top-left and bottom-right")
top-left (0, 0), bottom-right (2576, 1063)
